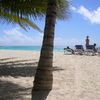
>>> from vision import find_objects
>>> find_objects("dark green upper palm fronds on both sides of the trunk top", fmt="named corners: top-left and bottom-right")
top-left (0, 0), bottom-right (69, 19)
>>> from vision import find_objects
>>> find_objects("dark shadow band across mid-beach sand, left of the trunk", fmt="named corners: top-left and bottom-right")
top-left (0, 58), bottom-right (37, 77)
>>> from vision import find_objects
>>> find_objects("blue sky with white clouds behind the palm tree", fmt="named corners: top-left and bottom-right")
top-left (0, 0), bottom-right (100, 47)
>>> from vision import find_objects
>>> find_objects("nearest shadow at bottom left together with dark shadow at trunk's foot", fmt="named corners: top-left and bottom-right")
top-left (0, 80), bottom-right (50, 100)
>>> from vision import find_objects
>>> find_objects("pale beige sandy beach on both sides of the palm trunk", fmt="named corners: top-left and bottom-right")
top-left (0, 50), bottom-right (100, 100)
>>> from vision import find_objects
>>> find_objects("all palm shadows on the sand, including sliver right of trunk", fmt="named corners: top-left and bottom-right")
top-left (0, 58), bottom-right (64, 100)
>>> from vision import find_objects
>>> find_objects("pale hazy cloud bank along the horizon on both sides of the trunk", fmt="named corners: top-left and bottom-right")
top-left (0, 28), bottom-right (82, 47)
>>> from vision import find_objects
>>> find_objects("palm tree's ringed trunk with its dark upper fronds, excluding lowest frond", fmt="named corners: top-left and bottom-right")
top-left (0, 0), bottom-right (68, 97)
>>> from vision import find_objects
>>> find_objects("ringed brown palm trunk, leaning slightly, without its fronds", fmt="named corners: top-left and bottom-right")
top-left (32, 0), bottom-right (57, 91)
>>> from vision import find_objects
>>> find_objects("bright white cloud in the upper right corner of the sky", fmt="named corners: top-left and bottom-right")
top-left (72, 6), bottom-right (100, 24)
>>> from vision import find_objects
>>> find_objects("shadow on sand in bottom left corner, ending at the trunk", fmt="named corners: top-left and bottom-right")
top-left (0, 80), bottom-right (31, 100)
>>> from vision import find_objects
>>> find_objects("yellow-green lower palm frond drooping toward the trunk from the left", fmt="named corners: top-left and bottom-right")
top-left (0, 12), bottom-right (42, 32)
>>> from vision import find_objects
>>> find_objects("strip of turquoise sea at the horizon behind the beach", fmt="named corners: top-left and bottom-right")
top-left (0, 46), bottom-right (63, 52)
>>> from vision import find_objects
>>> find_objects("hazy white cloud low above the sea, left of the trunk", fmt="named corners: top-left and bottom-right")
top-left (0, 28), bottom-right (42, 45)
